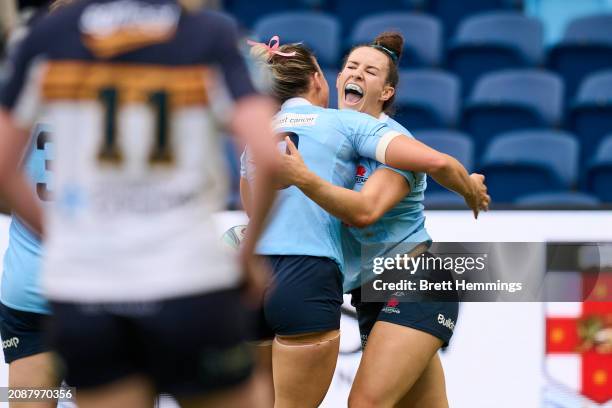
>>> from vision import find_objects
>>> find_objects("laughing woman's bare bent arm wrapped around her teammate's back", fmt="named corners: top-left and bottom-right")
top-left (281, 138), bottom-right (410, 228)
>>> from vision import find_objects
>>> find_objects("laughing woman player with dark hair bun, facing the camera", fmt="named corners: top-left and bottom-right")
top-left (284, 33), bottom-right (490, 408)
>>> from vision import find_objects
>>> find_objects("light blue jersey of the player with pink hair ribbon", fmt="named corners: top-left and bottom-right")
top-left (242, 98), bottom-right (398, 270)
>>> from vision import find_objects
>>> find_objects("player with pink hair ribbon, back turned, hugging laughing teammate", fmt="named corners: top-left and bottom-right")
top-left (241, 39), bottom-right (490, 407)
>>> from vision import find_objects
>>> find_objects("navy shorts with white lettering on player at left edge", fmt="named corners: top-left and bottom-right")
top-left (0, 303), bottom-right (50, 363)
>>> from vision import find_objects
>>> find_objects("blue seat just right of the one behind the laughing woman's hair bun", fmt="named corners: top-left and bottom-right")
top-left (447, 12), bottom-right (544, 95)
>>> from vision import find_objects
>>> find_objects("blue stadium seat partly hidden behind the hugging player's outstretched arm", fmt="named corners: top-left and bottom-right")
top-left (414, 129), bottom-right (474, 193)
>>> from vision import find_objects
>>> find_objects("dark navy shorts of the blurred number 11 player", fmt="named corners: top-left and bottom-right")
top-left (51, 290), bottom-right (253, 397)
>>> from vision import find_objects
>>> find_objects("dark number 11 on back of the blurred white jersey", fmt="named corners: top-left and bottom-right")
top-left (98, 88), bottom-right (173, 164)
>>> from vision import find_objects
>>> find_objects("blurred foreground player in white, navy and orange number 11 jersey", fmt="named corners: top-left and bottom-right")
top-left (0, 0), bottom-right (275, 408)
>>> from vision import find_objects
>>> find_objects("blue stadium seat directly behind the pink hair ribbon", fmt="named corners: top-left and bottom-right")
top-left (254, 12), bottom-right (340, 67)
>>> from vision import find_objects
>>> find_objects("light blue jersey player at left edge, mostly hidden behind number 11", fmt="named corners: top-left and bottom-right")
top-left (0, 1), bottom-right (70, 407)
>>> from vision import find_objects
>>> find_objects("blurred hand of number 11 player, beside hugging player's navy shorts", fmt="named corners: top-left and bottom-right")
top-left (240, 252), bottom-right (272, 307)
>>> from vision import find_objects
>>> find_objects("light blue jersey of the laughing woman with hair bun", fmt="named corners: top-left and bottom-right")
top-left (342, 113), bottom-right (431, 292)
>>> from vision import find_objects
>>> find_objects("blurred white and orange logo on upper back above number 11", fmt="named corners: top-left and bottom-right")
top-left (80, 0), bottom-right (180, 58)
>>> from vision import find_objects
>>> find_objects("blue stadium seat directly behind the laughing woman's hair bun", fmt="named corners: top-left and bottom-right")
top-left (348, 12), bottom-right (443, 67)
